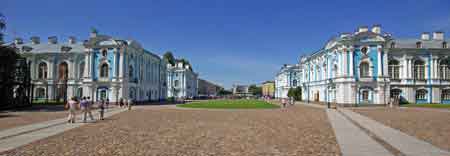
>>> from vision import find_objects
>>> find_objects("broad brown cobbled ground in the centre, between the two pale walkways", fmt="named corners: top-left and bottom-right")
top-left (0, 106), bottom-right (340, 156)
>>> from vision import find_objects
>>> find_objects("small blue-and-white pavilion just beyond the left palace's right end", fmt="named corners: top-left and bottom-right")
top-left (167, 61), bottom-right (198, 98)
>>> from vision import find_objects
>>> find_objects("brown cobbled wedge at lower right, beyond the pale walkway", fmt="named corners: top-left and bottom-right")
top-left (354, 108), bottom-right (450, 151)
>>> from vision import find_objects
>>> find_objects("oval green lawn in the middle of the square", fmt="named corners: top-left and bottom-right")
top-left (177, 100), bottom-right (279, 109)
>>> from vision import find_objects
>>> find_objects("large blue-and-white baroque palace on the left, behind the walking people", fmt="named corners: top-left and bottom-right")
top-left (13, 31), bottom-right (167, 102)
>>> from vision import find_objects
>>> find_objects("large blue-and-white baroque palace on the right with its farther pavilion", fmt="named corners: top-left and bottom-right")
top-left (276, 25), bottom-right (450, 105)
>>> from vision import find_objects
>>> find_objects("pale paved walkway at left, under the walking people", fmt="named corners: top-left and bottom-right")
top-left (0, 108), bottom-right (126, 153)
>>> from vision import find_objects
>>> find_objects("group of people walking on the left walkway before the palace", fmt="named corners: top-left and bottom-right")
top-left (65, 97), bottom-right (115, 123)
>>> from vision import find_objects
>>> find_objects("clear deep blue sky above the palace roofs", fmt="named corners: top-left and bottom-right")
top-left (0, 0), bottom-right (450, 88)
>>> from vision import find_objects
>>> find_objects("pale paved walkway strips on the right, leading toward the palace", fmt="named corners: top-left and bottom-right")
top-left (297, 102), bottom-right (450, 156)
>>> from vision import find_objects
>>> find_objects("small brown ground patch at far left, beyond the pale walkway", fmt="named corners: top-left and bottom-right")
top-left (0, 106), bottom-right (68, 130)
